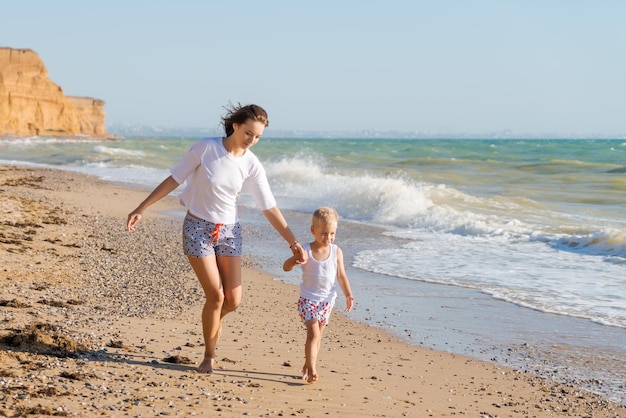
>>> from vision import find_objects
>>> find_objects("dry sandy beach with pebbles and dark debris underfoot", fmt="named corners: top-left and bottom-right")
top-left (0, 167), bottom-right (626, 418)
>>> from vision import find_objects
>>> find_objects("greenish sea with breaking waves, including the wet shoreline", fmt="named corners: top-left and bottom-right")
top-left (0, 136), bottom-right (626, 403)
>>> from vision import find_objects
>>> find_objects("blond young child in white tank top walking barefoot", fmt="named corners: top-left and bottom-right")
top-left (283, 207), bottom-right (354, 383)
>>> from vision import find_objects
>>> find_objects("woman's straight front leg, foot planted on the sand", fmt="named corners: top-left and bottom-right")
top-left (187, 255), bottom-right (224, 374)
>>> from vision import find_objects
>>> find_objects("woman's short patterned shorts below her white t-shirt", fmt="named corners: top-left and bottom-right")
top-left (183, 214), bottom-right (243, 257)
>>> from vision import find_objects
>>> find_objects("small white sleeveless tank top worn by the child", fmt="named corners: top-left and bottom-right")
top-left (300, 242), bottom-right (337, 303)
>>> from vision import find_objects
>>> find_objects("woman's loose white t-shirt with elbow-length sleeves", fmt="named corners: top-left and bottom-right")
top-left (170, 138), bottom-right (276, 224)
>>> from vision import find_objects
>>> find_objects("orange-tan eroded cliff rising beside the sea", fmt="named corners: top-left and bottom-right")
top-left (0, 47), bottom-right (110, 137)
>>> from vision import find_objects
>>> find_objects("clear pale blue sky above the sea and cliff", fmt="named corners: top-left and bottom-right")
top-left (0, 0), bottom-right (626, 135)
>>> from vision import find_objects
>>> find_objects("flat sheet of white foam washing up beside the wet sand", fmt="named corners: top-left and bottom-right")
top-left (354, 230), bottom-right (626, 328)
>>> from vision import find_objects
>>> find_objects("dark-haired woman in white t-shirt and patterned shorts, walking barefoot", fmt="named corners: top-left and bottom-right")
top-left (127, 104), bottom-right (307, 374)
